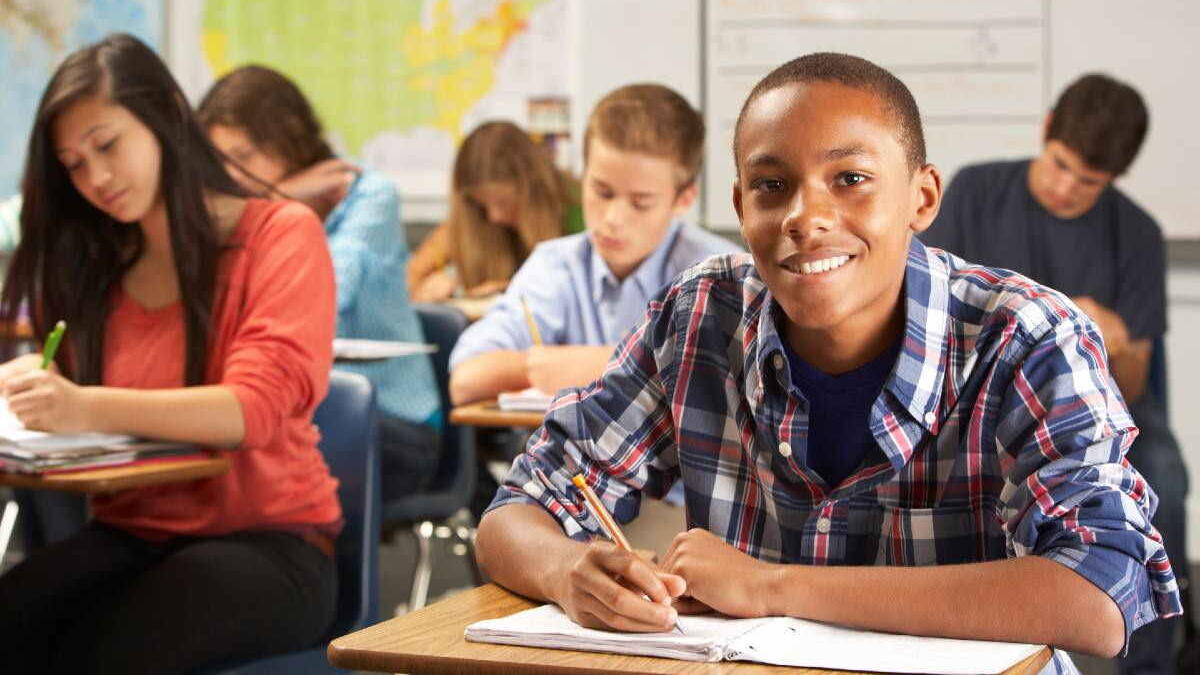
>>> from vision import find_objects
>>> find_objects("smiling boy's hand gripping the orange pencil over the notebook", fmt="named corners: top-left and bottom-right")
top-left (550, 542), bottom-right (685, 633)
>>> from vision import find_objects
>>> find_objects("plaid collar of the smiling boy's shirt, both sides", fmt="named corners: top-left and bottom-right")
top-left (754, 237), bottom-right (950, 432)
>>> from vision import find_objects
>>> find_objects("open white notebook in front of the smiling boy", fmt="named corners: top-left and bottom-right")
top-left (466, 604), bottom-right (1042, 675)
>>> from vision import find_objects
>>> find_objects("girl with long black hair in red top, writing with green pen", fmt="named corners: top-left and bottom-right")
top-left (0, 35), bottom-right (342, 674)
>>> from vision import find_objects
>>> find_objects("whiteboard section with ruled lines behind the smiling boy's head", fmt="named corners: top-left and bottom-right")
top-left (703, 0), bottom-right (1049, 229)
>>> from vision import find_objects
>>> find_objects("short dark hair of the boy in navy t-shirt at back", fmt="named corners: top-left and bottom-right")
top-left (1046, 73), bottom-right (1150, 175)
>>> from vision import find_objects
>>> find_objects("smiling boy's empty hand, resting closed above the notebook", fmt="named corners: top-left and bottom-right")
top-left (660, 528), bottom-right (778, 617)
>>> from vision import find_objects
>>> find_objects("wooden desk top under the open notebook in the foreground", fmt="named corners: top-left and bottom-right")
top-left (328, 584), bottom-right (1050, 675)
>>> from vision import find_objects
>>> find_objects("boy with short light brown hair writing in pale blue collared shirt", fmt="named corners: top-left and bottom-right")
top-left (450, 84), bottom-right (737, 405)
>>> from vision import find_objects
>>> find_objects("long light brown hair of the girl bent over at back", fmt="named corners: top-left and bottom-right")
top-left (446, 121), bottom-right (572, 288)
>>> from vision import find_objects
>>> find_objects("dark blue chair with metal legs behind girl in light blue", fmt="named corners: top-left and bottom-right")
top-left (383, 304), bottom-right (480, 611)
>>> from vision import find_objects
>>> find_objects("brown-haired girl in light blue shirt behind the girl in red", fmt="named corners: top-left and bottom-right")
top-left (197, 66), bottom-right (442, 501)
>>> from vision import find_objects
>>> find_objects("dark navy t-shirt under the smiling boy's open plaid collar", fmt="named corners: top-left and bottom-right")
top-left (784, 340), bottom-right (900, 488)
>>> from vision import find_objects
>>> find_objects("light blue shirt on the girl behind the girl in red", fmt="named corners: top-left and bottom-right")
top-left (325, 171), bottom-right (442, 426)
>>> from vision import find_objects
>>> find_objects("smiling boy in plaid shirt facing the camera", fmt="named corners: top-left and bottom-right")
top-left (478, 54), bottom-right (1180, 673)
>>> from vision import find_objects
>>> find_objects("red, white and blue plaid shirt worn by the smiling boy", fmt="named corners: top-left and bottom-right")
top-left (491, 239), bottom-right (1181, 670)
